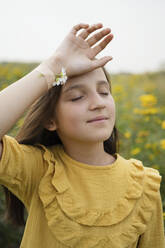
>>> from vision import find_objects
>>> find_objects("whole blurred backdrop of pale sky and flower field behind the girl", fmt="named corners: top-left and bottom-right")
top-left (0, 0), bottom-right (165, 248)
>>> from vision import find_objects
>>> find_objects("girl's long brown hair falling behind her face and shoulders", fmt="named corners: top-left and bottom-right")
top-left (3, 67), bottom-right (119, 226)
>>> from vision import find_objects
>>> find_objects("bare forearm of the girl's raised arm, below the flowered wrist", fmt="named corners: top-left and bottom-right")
top-left (0, 56), bottom-right (59, 139)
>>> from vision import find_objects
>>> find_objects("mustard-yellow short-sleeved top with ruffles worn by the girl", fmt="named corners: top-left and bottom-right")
top-left (0, 135), bottom-right (165, 248)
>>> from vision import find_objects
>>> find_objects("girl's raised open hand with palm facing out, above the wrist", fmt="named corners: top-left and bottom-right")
top-left (49, 23), bottom-right (113, 76)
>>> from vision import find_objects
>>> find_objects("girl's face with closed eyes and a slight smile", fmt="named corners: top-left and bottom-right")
top-left (51, 68), bottom-right (115, 145)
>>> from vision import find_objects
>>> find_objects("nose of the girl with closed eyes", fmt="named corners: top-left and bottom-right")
top-left (89, 93), bottom-right (105, 110)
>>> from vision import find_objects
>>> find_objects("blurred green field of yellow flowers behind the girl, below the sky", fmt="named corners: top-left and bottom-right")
top-left (0, 63), bottom-right (165, 223)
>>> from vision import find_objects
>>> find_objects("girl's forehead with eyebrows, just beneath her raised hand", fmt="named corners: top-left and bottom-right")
top-left (62, 68), bottom-right (109, 93)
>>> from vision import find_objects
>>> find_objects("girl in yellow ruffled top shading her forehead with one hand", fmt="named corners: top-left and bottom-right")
top-left (0, 23), bottom-right (165, 248)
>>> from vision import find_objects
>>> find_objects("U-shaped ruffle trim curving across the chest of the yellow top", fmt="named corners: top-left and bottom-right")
top-left (39, 145), bottom-right (161, 248)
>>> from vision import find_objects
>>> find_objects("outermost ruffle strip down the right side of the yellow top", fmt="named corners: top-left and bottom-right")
top-left (120, 159), bottom-right (162, 247)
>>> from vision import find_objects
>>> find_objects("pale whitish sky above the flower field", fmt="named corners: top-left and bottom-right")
top-left (0, 0), bottom-right (165, 73)
